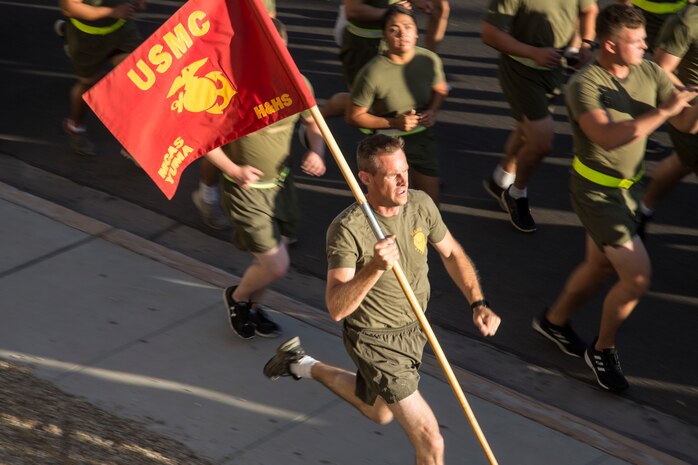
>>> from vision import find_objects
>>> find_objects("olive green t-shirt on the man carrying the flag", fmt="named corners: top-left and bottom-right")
top-left (327, 190), bottom-right (447, 328)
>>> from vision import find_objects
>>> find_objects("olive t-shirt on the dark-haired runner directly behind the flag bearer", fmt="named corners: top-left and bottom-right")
top-left (351, 47), bottom-right (445, 117)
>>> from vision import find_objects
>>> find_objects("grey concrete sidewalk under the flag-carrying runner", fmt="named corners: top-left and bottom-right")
top-left (0, 185), bottom-right (683, 465)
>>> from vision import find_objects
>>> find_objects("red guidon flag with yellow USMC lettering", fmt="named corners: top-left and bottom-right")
top-left (83, 0), bottom-right (315, 199)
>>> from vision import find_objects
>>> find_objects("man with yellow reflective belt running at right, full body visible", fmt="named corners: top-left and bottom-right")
top-left (533, 3), bottom-right (698, 391)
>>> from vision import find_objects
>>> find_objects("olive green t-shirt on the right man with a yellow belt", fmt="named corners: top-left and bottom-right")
top-left (565, 60), bottom-right (674, 179)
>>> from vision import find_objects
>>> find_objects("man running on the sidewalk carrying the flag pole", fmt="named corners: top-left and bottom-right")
top-left (264, 134), bottom-right (500, 465)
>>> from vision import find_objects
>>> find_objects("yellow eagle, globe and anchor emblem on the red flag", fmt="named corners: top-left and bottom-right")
top-left (167, 58), bottom-right (237, 115)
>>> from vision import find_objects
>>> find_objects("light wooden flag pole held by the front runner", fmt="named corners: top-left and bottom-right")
top-left (310, 105), bottom-right (498, 465)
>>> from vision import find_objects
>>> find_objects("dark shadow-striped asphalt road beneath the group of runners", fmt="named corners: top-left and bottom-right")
top-left (0, 0), bottom-right (698, 452)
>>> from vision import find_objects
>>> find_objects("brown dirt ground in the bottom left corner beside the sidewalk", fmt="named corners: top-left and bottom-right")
top-left (0, 360), bottom-right (211, 465)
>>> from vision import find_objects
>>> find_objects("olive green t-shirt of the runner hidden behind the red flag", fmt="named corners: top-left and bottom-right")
top-left (221, 76), bottom-right (313, 182)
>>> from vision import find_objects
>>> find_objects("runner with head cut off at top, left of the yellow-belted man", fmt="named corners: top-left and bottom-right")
top-left (482, 0), bottom-right (598, 233)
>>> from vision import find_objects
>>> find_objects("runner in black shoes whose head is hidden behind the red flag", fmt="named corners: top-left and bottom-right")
top-left (205, 18), bottom-right (325, 339)
